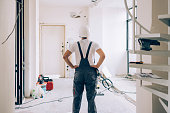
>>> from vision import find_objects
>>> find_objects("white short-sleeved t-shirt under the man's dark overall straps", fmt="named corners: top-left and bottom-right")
top-left (69, 39), bottom-right (100, 65)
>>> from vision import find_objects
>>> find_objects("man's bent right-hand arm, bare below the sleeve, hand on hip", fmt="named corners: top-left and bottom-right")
top-left (91, 49), bottom-right (105, 68)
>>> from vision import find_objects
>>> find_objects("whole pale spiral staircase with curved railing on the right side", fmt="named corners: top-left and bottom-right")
top-left (124, 0), bottom-right (170, 113)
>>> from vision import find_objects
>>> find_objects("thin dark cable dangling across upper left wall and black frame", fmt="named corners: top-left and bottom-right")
top-left (2, 1), bottom-right (23, 45)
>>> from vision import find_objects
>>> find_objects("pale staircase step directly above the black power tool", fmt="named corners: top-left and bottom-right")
top-left (136, 33), bottom-right (170, 42)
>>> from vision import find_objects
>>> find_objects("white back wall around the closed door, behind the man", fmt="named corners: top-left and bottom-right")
top-left (39, 2), bottom-right (88, 77)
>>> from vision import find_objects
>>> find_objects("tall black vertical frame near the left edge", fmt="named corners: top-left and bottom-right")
top-left (15, 0), bottom-right (25, 105)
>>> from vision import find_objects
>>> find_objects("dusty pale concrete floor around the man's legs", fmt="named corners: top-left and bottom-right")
top-left (15, 79), bottom-right (136, 113)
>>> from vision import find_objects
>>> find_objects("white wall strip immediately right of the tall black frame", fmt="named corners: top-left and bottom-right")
top-left (24, 0), bottom-right (39, 97)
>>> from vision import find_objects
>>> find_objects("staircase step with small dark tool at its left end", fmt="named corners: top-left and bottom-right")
top-left (129, 63), bottom-right (170, 72)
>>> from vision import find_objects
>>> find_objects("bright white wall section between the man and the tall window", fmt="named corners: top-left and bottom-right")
top-left (103, 8), bottom-right (127, 76)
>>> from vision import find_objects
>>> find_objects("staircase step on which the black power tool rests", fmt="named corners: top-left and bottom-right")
top-left (129, 50), bottom-right (170, 57)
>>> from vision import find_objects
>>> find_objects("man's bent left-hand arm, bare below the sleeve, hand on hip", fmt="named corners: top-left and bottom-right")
top-left (63, 50), bottom-right (78, 69)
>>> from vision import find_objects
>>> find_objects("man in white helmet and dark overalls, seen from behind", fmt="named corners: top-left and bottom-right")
top-left (63, 26), bottom-right (105, 113)
